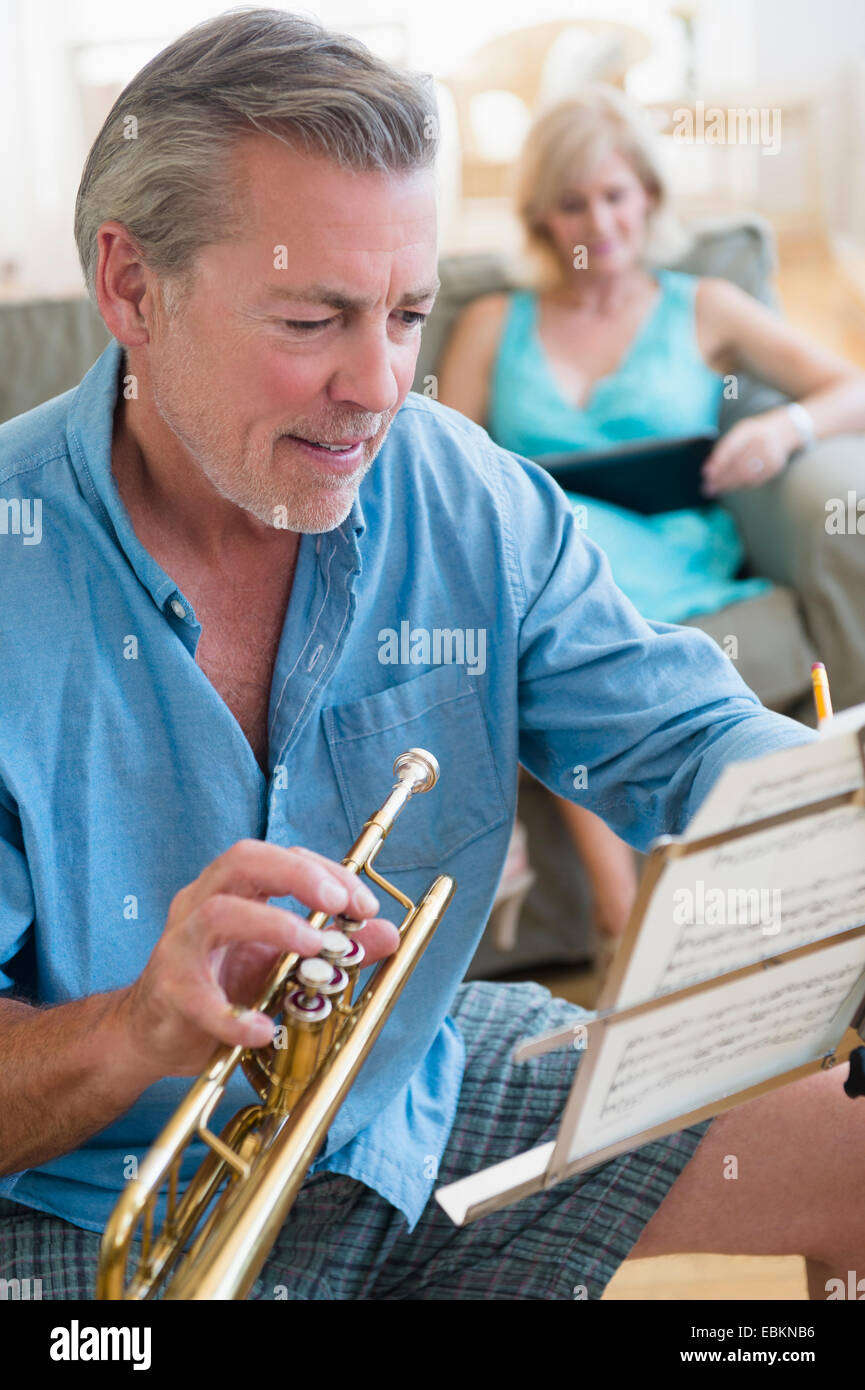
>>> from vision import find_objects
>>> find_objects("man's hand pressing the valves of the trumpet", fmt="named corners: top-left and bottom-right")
top-left (117, 840), bottom-right (399, 1080)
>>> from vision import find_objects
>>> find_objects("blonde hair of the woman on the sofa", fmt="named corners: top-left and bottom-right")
top-left (516, 83), bottom-right (690, 284)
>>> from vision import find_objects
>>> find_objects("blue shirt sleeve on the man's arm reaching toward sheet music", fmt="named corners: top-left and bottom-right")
top-left (505, 455), bottom-right (816, 851)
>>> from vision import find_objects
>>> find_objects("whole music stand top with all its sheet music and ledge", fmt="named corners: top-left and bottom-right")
top-left (435, 728), bottom-right (865, 1225)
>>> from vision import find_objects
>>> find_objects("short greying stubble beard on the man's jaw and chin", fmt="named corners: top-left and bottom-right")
top-left (150, 316), bottom-right (394, 535)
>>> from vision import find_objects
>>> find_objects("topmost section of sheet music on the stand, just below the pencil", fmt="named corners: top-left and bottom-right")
top-left (683, 705), bottom-right (865, 842)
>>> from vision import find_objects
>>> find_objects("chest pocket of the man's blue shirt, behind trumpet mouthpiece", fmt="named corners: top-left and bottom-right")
top-left (323, 666), bottom-right (508, 876)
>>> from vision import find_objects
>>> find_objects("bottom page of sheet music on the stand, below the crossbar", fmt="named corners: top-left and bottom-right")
top-left (569, 937), bottom-right (865, 1162)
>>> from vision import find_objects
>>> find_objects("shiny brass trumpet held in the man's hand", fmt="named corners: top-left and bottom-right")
top-left (96, 748), bottom-right (455, 1300)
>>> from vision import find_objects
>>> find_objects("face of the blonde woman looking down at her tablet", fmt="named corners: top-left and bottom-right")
top-left (544, 154), bottom-right (654, 275)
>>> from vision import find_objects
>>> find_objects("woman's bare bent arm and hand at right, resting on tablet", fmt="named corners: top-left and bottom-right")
top-left (697, 279), bottom-right (865, 496)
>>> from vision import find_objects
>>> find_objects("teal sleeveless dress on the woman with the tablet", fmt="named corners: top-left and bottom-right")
top-left (487, 270), bottom-right (772, 623)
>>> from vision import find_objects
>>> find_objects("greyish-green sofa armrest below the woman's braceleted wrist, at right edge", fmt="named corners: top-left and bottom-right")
top-left (723, 435), bottom-right (865, 709)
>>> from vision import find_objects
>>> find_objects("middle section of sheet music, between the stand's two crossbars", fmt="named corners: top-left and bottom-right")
top-left (616, 805), bottom-right (865, 1009)
